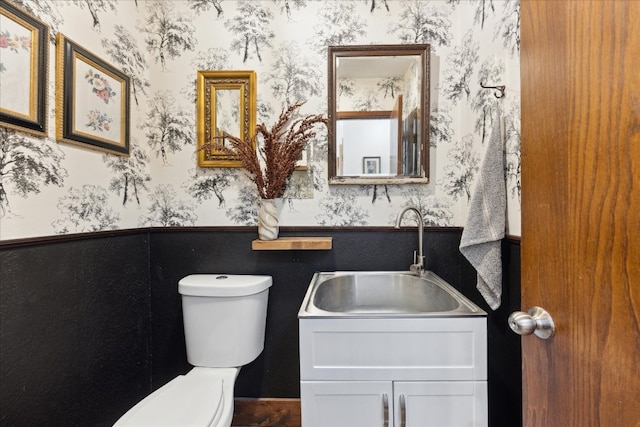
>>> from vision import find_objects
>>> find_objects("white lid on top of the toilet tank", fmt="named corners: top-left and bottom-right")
top-left (178, 274), bottom-right (273, 297)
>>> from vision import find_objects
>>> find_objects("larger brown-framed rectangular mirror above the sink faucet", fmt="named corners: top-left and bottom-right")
top-left (328, 44), bottom-right (430, 184)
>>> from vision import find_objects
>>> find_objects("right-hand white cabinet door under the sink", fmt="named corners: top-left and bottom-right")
top-left (394, 381), bottom-right (488, 427)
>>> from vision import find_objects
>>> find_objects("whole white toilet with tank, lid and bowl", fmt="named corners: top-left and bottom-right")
top-left (114, 274), bottom-right (272, 427)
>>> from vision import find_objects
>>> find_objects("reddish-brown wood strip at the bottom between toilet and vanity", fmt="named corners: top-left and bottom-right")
top-left (231, 398), bottom-right (302, 427)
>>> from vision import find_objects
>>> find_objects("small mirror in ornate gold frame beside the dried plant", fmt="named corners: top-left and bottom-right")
top-left (196, 71), bottom-right (256, 168)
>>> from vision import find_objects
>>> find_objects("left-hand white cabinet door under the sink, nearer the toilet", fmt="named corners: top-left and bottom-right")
top-left (300, 381), bottom-right (393, 427)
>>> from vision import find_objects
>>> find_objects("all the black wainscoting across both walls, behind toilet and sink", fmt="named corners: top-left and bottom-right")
top-left (0, 227), bottom-right (521, 427)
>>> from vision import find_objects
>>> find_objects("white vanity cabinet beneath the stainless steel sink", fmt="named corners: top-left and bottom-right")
top-left (300, 316), bottom-right (488, 427)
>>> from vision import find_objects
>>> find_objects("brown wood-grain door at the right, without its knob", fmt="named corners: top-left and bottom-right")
top-left (521, 0), bottom-right (640, 427)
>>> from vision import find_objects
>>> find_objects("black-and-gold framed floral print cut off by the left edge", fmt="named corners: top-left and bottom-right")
top-left (0, 0), bottom-right (49, 136)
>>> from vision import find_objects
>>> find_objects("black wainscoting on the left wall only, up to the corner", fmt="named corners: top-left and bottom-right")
top-left (0, 232), bottom-right (151, 427)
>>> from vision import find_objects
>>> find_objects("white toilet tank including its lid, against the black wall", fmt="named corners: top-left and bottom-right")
top-left (178, 274), bottom-right (272, 368)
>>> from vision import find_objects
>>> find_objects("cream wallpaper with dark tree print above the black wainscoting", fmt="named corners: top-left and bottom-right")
top-left (0, 0), bottom-right (520, 240)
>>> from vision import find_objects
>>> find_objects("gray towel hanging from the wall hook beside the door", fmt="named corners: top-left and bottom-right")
top-left (460, 113), bottom-right (507, 310)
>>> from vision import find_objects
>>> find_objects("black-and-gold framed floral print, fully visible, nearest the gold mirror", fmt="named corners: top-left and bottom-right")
top-left (56, 33), bottom-right (130, 156)
